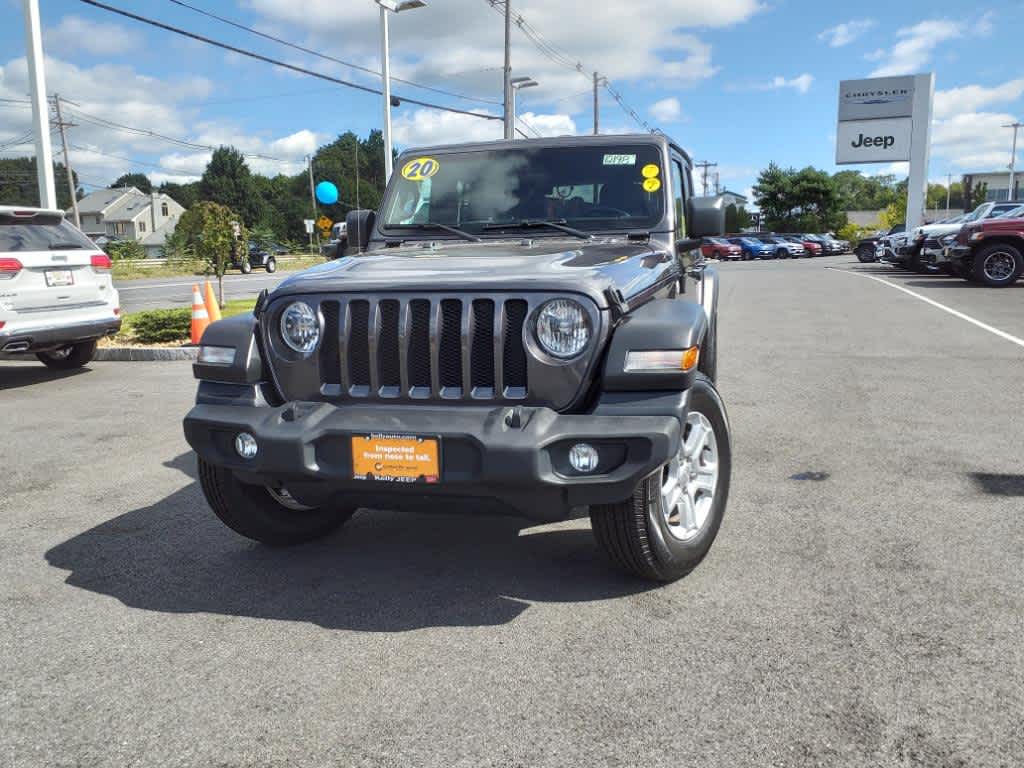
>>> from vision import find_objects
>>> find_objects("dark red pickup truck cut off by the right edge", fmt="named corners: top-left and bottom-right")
top-left (944, 214), bottom-right (1024, 288)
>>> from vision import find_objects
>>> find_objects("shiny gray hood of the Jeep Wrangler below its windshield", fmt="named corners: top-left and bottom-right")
top-left (270, 238), bottom-right (675, 308)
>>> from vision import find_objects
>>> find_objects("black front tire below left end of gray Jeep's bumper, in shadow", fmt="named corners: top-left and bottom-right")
top-left (198, 459), bottom-right (355, 547)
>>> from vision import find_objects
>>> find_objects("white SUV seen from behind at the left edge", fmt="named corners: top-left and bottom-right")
top-left (0, 206), bottom-right (121, 369)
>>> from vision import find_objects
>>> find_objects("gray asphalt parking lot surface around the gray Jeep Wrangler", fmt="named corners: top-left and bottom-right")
top-left (0, 256), bottom-right (1024, 768)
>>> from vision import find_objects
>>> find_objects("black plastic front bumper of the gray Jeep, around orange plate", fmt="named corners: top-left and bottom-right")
top-left (184, 392), bottom-right (689, 521)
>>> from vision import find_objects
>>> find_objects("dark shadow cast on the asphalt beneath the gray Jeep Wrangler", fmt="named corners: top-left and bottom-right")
top-left (46, 454), bottom-right (652, 632)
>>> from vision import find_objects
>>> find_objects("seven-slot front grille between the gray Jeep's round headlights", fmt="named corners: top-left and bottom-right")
top-left (319, 295), bottom-right (529, 400)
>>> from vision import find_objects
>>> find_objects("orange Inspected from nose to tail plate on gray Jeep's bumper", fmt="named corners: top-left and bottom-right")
top-left (350, 432), bottom-right (441, 483)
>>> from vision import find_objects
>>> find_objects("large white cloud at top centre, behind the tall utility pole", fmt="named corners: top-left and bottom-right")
top-left (248, 0), bottom-right (764, 105)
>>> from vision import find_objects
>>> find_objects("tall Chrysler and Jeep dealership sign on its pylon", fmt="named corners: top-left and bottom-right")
top-left (836, 74), bottom-right (935, 230)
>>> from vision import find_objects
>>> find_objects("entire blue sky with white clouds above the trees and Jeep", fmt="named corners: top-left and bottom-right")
top-left (0, 0), bottom-right (1024, 204)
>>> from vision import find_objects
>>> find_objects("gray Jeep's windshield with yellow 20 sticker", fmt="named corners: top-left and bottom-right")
top-left (380, 145), bottom-right (665, 238)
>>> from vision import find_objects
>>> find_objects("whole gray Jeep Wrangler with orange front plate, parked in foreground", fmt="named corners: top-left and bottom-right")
top-left (184, 134), bottom-right (731, 581)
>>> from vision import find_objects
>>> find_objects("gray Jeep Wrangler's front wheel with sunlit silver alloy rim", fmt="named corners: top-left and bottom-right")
top-left (590, 375), bottom-right (732, 582)
